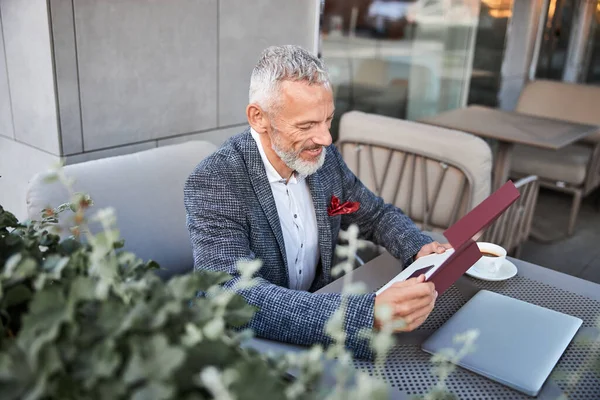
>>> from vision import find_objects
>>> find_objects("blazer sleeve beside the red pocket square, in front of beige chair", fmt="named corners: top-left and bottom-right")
top-left (330, 146), bottom-right (433, 265)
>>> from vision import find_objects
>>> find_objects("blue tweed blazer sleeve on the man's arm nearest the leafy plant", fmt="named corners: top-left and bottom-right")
top-left (184, 166), bottom-right (375, 358)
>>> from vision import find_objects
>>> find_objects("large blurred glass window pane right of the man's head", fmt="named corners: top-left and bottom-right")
top-left (320, 0), bottom-right (480, 139)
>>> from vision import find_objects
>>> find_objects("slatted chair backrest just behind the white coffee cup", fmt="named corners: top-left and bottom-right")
top-left (480, 175), bottom-right (539, 253)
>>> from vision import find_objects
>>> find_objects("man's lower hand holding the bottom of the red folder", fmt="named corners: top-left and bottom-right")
top-left (374, 275), bottom-right (437, 332)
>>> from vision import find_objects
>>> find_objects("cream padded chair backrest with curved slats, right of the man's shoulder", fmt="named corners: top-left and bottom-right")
top-left (337, 111), bottom-right (492, 232)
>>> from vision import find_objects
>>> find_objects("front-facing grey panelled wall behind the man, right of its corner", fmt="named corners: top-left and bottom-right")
top-left (56, 0), bottom-right (316, 158)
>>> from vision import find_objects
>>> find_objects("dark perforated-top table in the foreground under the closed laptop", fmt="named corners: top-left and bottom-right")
top-left (246, 253), bottom-right (600, 400)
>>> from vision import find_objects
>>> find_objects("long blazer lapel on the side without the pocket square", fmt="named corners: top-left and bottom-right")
top-left (242, 129), bottom-right (289, 286)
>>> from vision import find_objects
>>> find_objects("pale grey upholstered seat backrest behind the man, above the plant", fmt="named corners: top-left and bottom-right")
top-left (27, 141), bottom-right (216, 278)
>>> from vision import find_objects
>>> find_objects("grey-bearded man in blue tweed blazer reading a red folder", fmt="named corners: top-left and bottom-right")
top-left (184, 46), bottom-right (448, 357)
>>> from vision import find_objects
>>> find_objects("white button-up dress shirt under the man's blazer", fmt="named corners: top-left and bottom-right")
top-left (250, 129), bottom-right (320, 290)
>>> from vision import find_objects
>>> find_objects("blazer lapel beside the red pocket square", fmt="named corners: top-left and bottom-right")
top-left (306, 170), bottom-right (333, 276)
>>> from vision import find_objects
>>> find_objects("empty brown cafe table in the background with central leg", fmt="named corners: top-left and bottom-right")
top-left (419, 106), bottom-right (598, 190)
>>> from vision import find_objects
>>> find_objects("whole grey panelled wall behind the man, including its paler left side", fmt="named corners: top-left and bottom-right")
top-left (0, 0), bottom-right (319, 219)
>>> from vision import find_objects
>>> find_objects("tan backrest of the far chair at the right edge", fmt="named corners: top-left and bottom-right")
top-left (515, 79), bottom-right (600, 143)
